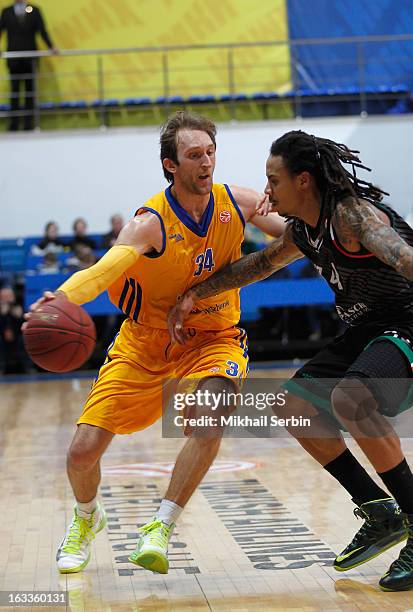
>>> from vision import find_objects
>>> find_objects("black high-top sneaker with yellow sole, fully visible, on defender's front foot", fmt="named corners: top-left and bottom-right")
top-left (333, 497), bottom-right (407, 572)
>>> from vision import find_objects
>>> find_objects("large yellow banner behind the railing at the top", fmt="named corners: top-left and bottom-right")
top-left (0, 0), bottom-right (291, 102)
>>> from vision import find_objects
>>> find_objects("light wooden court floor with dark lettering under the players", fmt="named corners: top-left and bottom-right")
top-left (0, 371), bottom-right (413, 612)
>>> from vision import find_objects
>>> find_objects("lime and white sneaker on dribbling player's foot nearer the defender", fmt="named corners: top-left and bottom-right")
top-left (129, 517), bottom-right (175, 574)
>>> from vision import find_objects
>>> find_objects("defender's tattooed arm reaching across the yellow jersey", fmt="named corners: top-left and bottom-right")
top-left (168, 225), bottom-right (303, 344)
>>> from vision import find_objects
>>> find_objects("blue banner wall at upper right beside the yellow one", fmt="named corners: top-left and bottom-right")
top-left (287, 0), bottom-right (413, 90)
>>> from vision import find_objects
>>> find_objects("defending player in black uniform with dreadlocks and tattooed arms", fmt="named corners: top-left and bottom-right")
top-left (169, 131), bottom-right (413, 591)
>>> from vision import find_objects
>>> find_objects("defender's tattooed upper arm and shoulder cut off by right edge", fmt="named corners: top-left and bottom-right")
top-left (333, 198), bottom-right (413, 280)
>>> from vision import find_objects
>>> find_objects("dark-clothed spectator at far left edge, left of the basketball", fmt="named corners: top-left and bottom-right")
top-left (0, 287), bottom-right (25, 374)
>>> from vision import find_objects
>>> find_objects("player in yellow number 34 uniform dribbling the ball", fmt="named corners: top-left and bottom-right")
top-left (26, 112), bottom-right (284, 573)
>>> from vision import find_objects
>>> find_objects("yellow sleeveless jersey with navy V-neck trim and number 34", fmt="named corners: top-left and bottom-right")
top-left (109, 184), bottom-right (245, 330)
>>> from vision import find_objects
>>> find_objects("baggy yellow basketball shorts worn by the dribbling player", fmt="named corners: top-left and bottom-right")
top-left (77, 319), bottom-right (248, 434)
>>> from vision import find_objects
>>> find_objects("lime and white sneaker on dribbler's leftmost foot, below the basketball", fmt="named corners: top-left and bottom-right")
top-left (56, 502), bottom-right (107, 574)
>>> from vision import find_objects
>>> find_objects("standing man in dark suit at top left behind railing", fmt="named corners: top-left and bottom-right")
top-left (0, 0), bottom-right (57, 131)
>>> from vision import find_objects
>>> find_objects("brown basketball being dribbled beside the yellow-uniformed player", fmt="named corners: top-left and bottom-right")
top-left (23, 297), bottom-right (96, 372)
